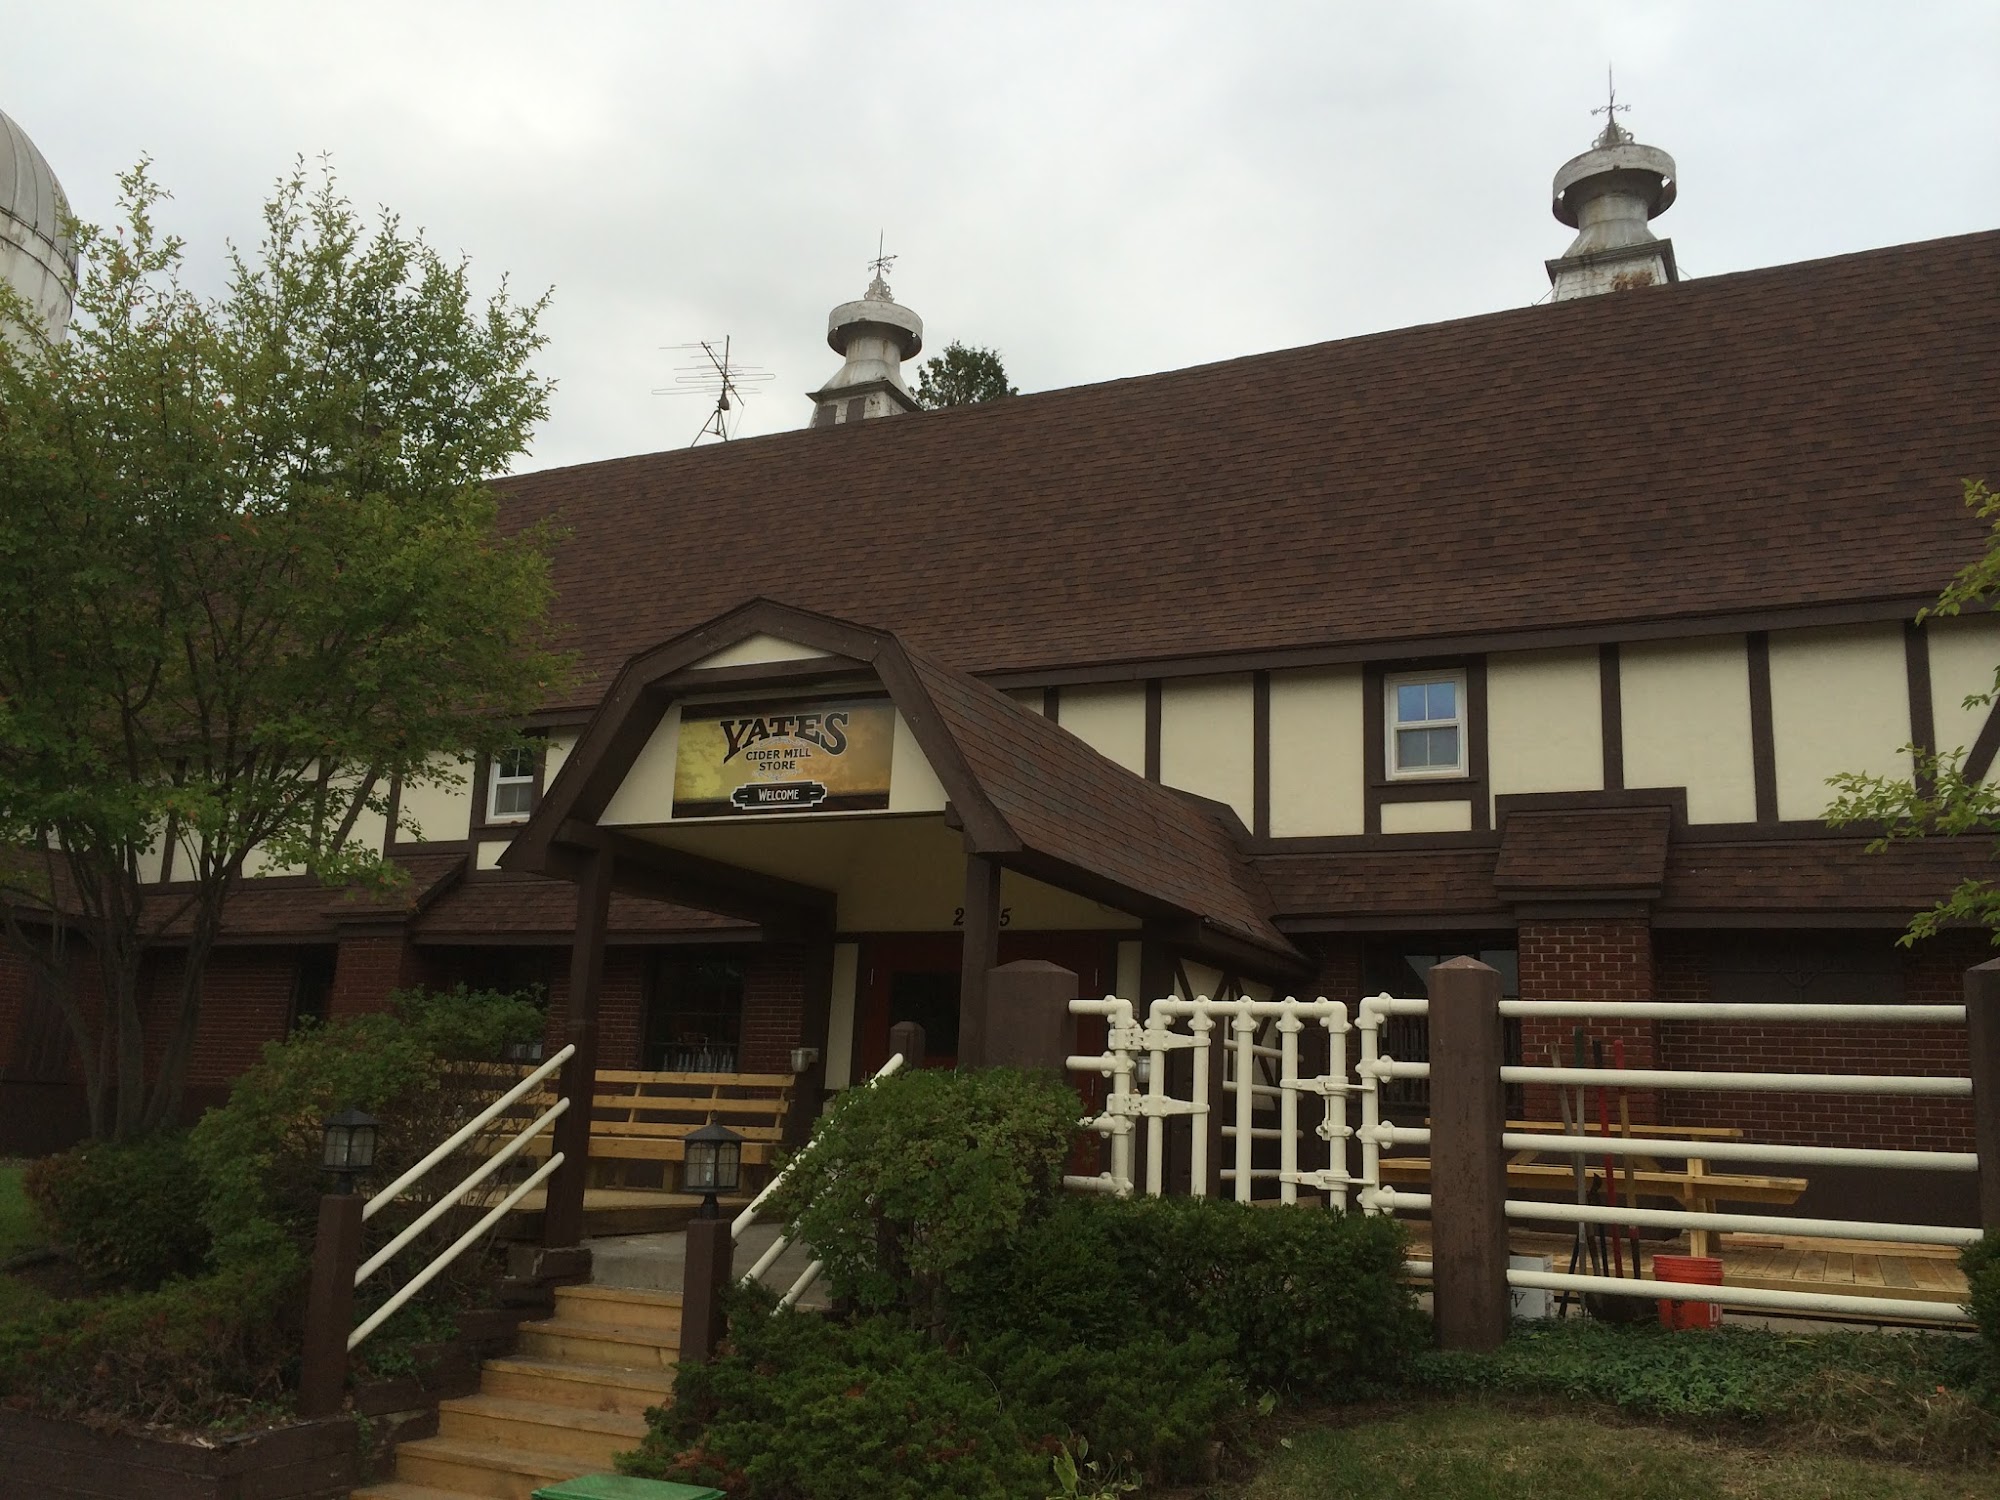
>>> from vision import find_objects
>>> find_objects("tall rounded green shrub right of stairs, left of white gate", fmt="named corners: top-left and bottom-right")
top-left (772, 1068), bottom-right (1082, 1328)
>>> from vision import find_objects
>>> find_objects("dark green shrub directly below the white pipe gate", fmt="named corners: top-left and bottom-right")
top-left (952, 1198), bottom-right (1424, 1408)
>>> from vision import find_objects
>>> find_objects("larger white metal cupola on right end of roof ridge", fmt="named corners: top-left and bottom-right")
top-left (1546, 96), bottom-right (1680, 302)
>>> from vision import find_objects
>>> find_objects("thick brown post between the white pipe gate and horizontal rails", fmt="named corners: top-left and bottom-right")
top-left (1430, 958), bottom-right (1508, 1350)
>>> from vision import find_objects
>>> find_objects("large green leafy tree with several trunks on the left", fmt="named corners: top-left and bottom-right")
top-left (0, 164), bottom-right (566, 1138)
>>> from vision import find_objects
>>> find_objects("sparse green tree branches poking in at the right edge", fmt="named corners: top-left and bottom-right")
top-left (1826, 480), bottom-right (2000, 944)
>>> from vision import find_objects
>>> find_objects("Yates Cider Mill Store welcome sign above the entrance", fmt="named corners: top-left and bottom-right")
top-left (674, 698), bottom-right (896, 818)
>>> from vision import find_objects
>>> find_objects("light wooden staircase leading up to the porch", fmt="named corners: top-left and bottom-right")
top-left (354, 1286), bottom-right (680, 1500)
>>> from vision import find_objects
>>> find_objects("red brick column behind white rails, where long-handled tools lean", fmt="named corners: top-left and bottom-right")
top-left (1518, 916), bottom-right (1660, 1126)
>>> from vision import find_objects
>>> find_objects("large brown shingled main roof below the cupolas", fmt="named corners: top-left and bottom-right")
top-left (502, 234), bottom-right (2000, 704)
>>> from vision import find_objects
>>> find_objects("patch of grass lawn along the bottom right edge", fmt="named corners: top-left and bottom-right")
top-left (1232, 1398), bottom-right (2000, 1500)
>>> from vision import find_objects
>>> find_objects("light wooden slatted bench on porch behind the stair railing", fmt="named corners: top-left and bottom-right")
top-left (518, 1068), bottom-right (794, 1190)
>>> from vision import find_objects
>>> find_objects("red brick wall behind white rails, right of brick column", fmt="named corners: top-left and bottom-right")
top-left (1658, 932), bottom-right (1990, 1176)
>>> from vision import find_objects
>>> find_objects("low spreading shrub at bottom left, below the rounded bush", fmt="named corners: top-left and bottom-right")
top-left (0, 1268), bottom-right (302, 1428)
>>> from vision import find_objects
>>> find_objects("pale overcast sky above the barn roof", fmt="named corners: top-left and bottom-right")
top-left (0, 0), bottom-right (2000, 468)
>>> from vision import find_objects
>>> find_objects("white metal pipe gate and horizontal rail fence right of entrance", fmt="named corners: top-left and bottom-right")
top-left (1064, 994), bottom-right (1980, 1320)
